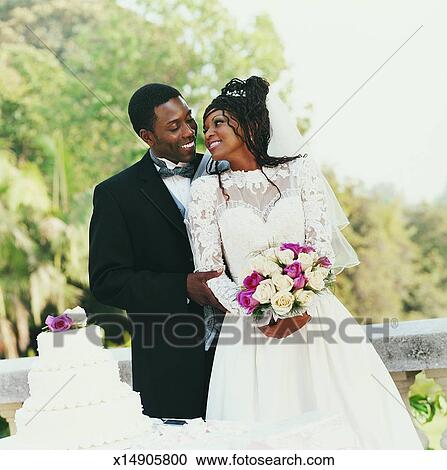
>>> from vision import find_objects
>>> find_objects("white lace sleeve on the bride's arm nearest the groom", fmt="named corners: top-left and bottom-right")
top-left (186, 176), bottom-right (245, 315)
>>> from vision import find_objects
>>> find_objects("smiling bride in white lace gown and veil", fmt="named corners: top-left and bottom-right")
top-left (186, 76), bottom-right (422, 449)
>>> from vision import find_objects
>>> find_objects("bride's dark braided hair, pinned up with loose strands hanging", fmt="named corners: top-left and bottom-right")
top-left (203, 75), bottom-right (302, 199)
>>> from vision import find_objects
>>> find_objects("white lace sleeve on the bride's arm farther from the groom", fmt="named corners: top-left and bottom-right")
top-left (301, 156), bottom-right (334, 261)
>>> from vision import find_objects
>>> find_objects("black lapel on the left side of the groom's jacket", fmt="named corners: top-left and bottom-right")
top-left (139, 152), bottom-right (188, 238)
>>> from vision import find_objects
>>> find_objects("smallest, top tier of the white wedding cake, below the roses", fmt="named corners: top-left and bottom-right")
top-left (37, 325), bottom-right (104, 361)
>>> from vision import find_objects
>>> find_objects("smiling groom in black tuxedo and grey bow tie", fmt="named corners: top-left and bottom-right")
top-left (89, 83), bottom-right (224, 418)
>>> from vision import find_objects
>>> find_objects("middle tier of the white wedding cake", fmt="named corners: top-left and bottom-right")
top-left (23, 360), bottom-right (130, 411)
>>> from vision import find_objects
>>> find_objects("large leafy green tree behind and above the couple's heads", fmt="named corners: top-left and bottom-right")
top-left (0, 0), bottom-right (286, 197)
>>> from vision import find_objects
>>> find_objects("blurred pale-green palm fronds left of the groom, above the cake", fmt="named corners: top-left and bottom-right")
top-left (0, 151), bottom-right (85, 357)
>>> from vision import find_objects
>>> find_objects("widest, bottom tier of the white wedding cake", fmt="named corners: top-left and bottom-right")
top-left (16, 387), bottom-right (152, 449)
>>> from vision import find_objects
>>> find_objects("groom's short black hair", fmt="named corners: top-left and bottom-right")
top-left (127, 83), bottom-right (182, 135)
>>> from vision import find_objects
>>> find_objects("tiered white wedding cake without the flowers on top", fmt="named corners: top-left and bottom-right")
top-left (16, 312), bottom-right (152, 449)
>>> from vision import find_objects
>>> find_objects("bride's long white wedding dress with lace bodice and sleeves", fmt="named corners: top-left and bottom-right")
top-left (185, 157), bottom-right (423, 449)
